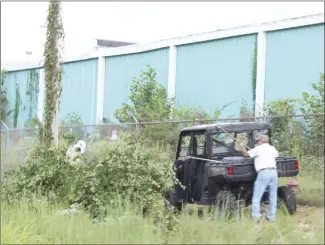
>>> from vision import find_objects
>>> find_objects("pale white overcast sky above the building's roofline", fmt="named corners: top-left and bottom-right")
top-left (1, 2), bottom-right (324, 63)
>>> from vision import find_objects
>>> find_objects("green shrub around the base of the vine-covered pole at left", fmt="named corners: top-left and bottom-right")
top-left (5, 145), bottom-right (78, 205)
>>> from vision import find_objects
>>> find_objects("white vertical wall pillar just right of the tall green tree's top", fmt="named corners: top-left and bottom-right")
top-left (167, 46), bottom-right (177, 99)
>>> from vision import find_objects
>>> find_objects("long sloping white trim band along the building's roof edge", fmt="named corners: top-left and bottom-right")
top-left (6, 14), bottom-right (324, 71)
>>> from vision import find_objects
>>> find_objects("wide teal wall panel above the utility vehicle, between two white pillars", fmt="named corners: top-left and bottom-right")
top-left (175, 35), bottom-right (256, 117)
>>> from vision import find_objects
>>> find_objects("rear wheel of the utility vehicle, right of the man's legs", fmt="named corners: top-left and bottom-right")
top-left (278, 186), bottom-right (297, 215)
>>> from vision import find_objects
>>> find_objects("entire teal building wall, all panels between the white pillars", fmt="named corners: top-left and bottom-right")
top-left (5, 24), bottom-right (324, 127)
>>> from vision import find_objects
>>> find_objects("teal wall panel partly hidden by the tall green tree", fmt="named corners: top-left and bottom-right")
top-left (104, 48), bottom-right (169, 121)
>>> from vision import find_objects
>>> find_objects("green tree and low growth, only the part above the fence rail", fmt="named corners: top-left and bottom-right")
top-left (115, 65), bottom-right (232, 123)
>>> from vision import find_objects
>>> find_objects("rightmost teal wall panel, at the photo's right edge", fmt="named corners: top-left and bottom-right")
top-left (265, 24), bottom-right (324, 103)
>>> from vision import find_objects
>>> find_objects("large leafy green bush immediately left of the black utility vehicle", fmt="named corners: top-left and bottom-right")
top-left (74, 135), bottom-right (173, 217)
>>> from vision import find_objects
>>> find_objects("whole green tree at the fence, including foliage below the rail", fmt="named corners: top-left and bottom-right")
top-left (114, 65), bottom-right (231, 145)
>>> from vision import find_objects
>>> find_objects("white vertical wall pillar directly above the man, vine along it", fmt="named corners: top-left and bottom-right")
top-left (255, 32), bottom-right (266, 117)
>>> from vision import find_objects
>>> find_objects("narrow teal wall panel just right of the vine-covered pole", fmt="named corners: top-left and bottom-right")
top-left (60, 59), bottom-right (98, 124)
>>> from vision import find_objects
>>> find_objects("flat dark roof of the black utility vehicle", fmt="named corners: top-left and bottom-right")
top-left (181, 122), bottom-right (271, 133)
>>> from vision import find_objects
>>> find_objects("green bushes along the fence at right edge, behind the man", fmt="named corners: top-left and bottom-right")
top-left (266, 74), bottom-right (324, 158)
